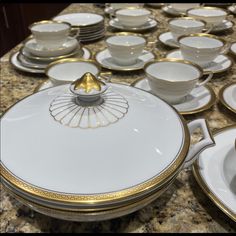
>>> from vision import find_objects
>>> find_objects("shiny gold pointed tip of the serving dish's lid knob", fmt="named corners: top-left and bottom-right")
top-left (72, 72), bottom-right (105, 93)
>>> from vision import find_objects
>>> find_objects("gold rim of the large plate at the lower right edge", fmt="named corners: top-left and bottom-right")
top-left (192, 125), bottom-right (236, 222)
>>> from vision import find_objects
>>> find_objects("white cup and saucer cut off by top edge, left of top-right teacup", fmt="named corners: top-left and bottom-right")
top-left (162, 3), bottom-right (200, 16)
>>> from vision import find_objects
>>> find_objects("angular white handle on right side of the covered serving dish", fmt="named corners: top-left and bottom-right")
top-left (183, 119), bottom-right (215, 168)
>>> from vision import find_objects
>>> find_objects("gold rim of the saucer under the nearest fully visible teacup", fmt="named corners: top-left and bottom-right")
top-left (130, 78), bottom-right (216, 115)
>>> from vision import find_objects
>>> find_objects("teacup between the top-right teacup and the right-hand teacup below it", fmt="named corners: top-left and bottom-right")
top-left (168, 17), bottom-right (211, 41)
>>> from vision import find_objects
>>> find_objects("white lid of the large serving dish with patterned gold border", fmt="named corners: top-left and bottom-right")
top-left (1, 83), bottom-right (190, 205)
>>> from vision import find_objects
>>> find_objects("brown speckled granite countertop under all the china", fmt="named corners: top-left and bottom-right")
top-left (0, 4), bottom-right (236, 233)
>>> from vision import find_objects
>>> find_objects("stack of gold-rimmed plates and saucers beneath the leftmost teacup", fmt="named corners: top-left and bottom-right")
top-left (10, 37), bottom-right (91, 73)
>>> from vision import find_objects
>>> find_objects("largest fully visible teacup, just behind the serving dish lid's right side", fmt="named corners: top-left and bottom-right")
top-left (144, 58), bottom-right (213, 104)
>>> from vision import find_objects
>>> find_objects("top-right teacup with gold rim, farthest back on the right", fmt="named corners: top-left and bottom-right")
top-left (187, 7), bottom-right (227, 26)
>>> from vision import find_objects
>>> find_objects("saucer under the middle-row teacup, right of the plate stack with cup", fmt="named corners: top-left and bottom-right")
top-left (95, 49), bottom-right (155, 71)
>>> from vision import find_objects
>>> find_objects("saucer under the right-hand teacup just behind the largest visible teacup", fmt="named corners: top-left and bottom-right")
top-left (166, 49), bottom-right (233, 74)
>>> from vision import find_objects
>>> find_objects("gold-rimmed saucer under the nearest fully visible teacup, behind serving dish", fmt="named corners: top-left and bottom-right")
top-left (131, 78), bottom-right (216, 115)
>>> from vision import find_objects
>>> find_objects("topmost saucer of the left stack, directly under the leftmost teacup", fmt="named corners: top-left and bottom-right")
top-left (24, 38), bottom-right (79, 57)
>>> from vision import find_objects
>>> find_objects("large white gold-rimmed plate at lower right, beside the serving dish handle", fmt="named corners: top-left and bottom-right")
top-left (193, 125), bottom-right (236, 222)
